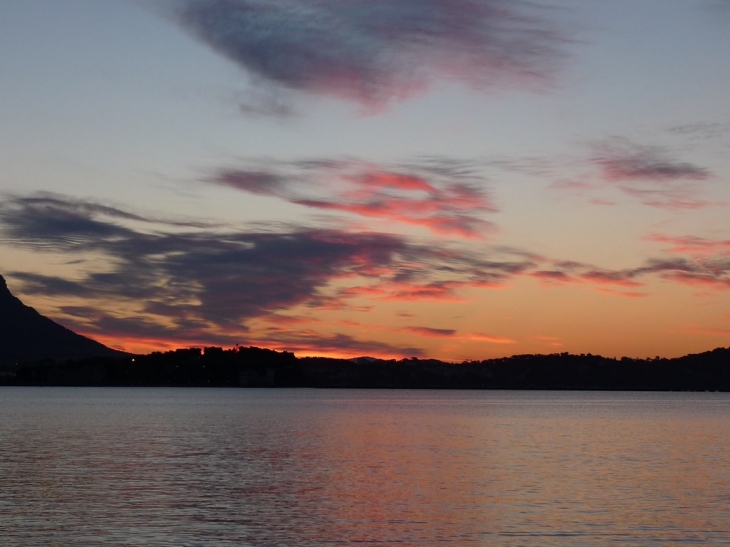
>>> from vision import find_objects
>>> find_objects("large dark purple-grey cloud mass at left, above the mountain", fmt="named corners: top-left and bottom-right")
top-left (0, 197), bottom-right (406, 323)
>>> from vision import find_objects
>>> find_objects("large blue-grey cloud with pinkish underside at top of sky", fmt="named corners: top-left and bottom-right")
top-left (170, 0), bottom-right (568, 108)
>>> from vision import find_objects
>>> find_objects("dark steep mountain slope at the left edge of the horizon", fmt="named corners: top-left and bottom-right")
top-left (0, 275), bottom-right (124, 365)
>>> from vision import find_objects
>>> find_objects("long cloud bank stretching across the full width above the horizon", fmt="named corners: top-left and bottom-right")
top-left (0, 193), bottom-right (730, 356)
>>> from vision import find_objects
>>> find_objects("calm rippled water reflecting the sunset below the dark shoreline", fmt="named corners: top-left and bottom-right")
top-left (0, 387), bottom-right (730, 547)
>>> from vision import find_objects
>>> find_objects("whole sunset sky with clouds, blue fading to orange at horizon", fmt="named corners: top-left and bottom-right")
top-left (0, 0), bottom-right (730, 361)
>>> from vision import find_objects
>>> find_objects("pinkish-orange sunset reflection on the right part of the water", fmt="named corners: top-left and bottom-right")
top-left (284, 392), bottom-right (730, 545)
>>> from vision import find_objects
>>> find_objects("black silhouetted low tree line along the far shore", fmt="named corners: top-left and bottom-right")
top-left (0, 347), bottom-right (730, 391)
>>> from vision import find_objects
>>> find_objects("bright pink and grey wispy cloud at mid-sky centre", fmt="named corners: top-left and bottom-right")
top-left (207, 158), bottom-right (497, 239)
